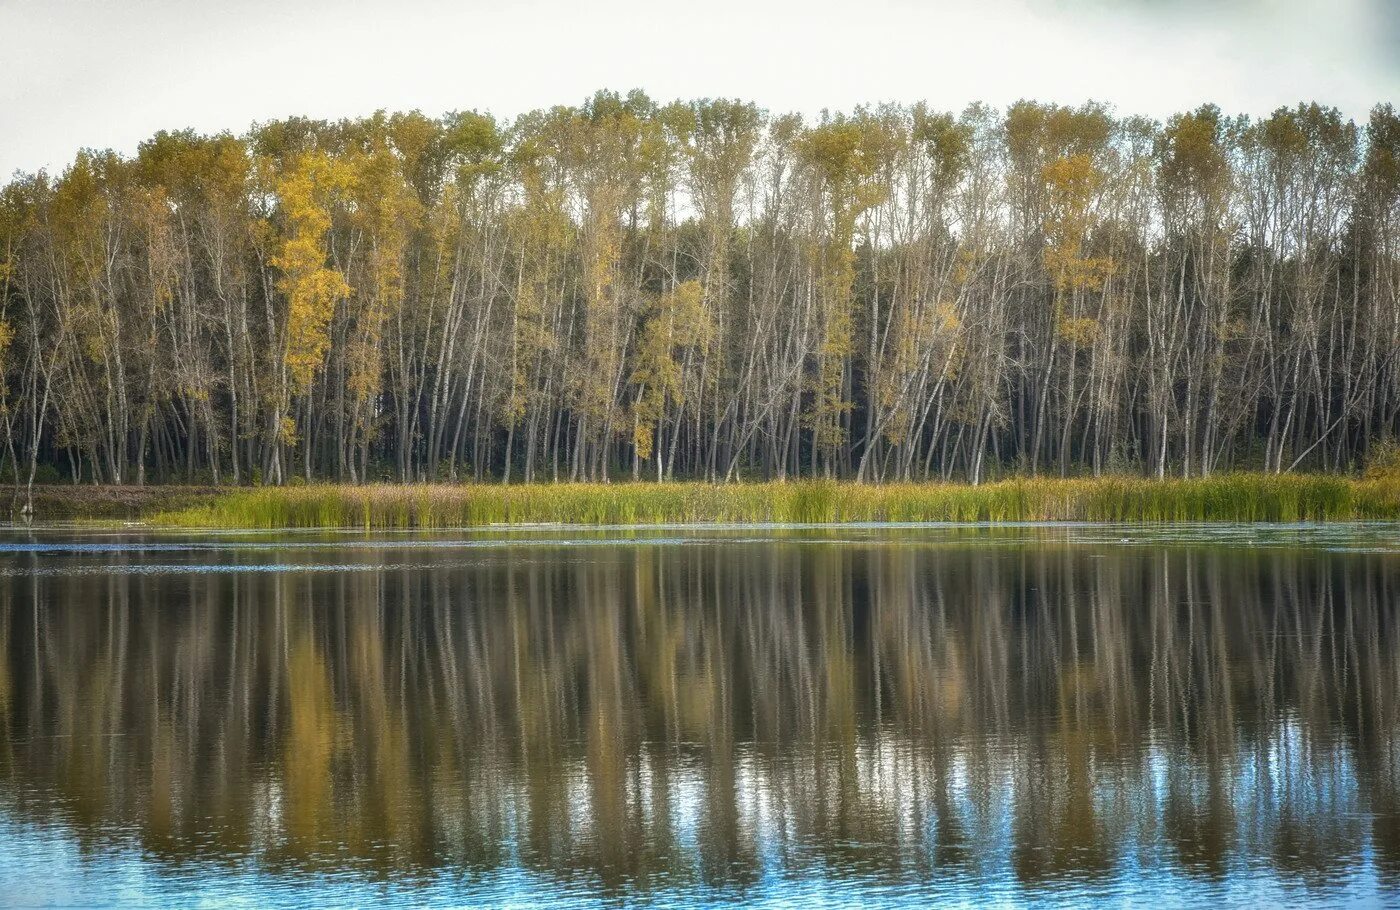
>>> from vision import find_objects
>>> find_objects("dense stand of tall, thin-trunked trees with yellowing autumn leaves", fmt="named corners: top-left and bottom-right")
top-left (0, 91), bottom-right (1400, 484)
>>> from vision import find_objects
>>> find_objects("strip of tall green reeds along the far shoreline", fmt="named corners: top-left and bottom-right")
top-left (153, 473), bottom-right (1400, 529)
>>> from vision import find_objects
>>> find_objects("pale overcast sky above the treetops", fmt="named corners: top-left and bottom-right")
top-left (0, 0), bottom-right (1400, 176)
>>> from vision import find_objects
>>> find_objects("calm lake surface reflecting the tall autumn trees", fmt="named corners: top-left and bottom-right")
top-left (0, 525), bottom-right (1400, 907)
